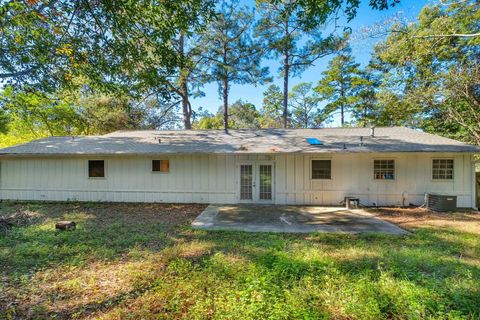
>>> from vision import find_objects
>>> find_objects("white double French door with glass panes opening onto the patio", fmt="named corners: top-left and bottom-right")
top-left (239, 162), bottom-right (274, 203)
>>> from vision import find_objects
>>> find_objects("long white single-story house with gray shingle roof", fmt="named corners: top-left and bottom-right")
top-left (0, 127), bottom-right (480, 207)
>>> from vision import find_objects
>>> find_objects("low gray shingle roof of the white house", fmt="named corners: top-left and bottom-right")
top-left (0, 127), bottom-right (480, 156)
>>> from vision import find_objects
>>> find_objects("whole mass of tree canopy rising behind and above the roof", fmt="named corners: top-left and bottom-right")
top-left (0, 0), bottom-right (480, 145)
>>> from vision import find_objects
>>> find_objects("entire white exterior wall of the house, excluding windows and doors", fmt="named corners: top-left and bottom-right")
top-left (0, 153), bottom-right (475, 207)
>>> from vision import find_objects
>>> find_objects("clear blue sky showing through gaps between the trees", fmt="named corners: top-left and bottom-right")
top-left (192, 0), bottom-right (431, 126)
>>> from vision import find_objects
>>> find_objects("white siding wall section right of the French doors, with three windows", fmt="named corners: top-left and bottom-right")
top-left (275, 153), bottom-right (474, 207)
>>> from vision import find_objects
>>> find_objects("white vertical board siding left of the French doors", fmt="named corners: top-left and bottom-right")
top-left (0, 155), bottom-right (235, 203)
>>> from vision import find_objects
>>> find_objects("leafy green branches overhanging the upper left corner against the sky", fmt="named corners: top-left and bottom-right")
top-left (0, 0), bottom-right (214, 93)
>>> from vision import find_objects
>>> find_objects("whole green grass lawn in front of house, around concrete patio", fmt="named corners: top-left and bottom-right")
top-left (0, 203), bottom-right (480, 319)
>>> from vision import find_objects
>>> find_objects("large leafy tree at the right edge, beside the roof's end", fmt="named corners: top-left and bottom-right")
top-left (375, 1), bottom-right (480, 144)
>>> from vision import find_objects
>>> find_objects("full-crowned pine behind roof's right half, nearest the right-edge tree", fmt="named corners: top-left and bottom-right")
top-left (315, 50), bottom-right (366, 127)
